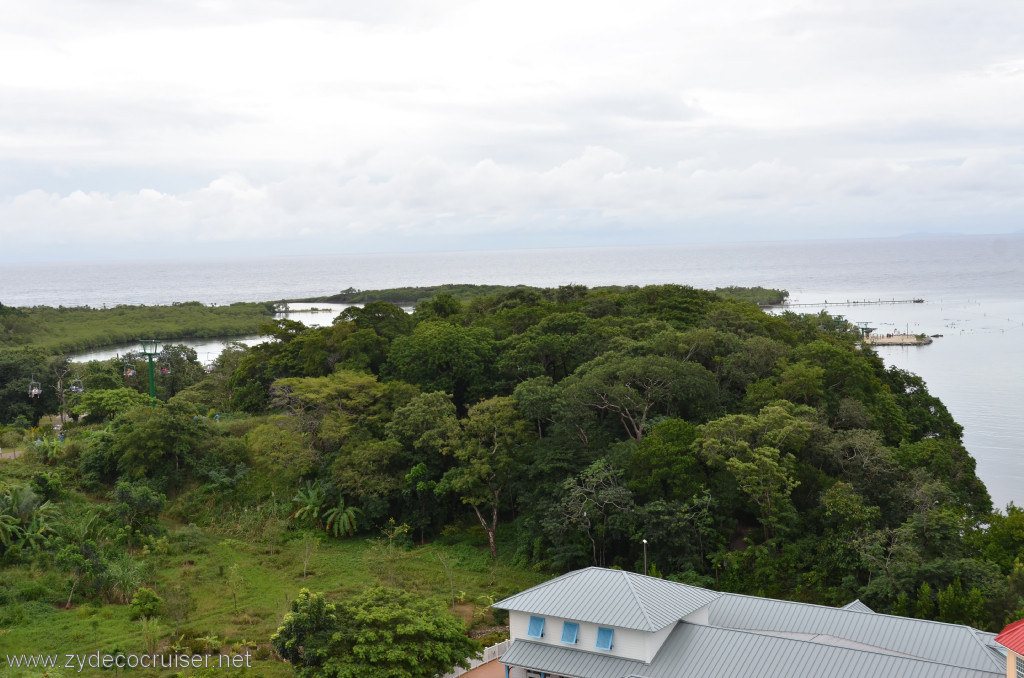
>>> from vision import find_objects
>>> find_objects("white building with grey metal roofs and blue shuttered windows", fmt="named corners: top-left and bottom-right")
top-left (495, 567), bottom-right (1007, 678)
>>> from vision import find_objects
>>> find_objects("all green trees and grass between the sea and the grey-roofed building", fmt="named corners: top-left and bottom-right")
top-left (0, 286), bottom-right (1024, 676)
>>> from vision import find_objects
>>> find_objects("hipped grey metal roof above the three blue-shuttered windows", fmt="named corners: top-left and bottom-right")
top-left (494, 567), bottom-right (722, 634)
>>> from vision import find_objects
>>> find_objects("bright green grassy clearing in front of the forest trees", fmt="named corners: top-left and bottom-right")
top-left (0, 457), bottom-right (548, 678)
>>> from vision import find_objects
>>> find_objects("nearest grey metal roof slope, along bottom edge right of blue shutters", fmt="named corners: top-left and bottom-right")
top-left (626, 626), bottom-right (1006, 678)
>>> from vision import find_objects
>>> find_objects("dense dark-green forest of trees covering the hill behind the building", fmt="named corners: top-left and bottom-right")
top-left (0, 285), bottom-right (1024, 675)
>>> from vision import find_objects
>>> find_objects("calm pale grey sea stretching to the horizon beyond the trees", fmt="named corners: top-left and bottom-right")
top-left (0, 236), bottom-right (1024, 506)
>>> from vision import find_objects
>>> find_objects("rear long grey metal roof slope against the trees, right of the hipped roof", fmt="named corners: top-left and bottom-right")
top-left (708, 594), bottom-right (1006, 675)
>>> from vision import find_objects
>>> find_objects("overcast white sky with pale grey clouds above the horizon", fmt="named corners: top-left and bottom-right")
top-left (0, 0), bottom-right (1024, 261)
